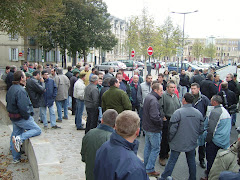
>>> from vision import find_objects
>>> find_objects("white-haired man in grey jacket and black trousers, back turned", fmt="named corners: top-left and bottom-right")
top-left (84, 75), bottom-right (99, 134)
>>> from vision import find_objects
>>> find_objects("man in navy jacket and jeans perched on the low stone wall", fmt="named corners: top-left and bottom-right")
top-left (6, 71), bottom-right (41, 163)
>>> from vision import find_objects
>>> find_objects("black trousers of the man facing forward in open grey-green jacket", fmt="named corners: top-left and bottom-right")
top-left (159, 118), bottom-right (170, 159)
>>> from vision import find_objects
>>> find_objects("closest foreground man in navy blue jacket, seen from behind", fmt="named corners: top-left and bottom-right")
top-left (94, 110), bottom-right (149, 180)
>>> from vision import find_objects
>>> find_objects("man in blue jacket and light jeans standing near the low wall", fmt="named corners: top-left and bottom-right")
top-left (40, 70), bottom-right (60, 130)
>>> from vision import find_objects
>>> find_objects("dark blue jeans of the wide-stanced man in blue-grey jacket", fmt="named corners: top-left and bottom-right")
top-left (160, 149), bottom-right (196, 180)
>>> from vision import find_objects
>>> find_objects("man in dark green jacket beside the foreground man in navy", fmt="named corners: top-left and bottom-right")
top-left (81, 109), bottom-right (118, 180)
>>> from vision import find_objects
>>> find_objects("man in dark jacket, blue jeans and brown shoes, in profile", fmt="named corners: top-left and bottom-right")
top-left (142, 83), bottom-right (163, 177)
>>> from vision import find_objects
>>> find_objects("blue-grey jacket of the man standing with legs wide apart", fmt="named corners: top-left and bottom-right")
top-left (169, 104), bottom-right (204, 152)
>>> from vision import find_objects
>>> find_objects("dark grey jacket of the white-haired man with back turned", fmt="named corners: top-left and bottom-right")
top-left (84, 83), bottom-right (99, 108)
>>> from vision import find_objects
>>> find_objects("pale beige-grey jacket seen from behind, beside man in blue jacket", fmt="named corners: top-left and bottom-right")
top-left (55, 74), bottom-right (70, 101)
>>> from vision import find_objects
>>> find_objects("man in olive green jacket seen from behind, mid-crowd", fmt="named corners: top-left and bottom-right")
top-left (102, 77), bottom-right (132, 114)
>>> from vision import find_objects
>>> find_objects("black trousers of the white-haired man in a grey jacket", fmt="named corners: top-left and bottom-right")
top-left (85, 108), bottom-right (98, 134)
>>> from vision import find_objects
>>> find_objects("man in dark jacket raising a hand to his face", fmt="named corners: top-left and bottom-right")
top-left (26, 70), bottom-right (45, 122)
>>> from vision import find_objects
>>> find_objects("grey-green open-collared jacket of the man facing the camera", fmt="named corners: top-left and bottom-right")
top-left (159, 91), bottom-right (181, 118)
